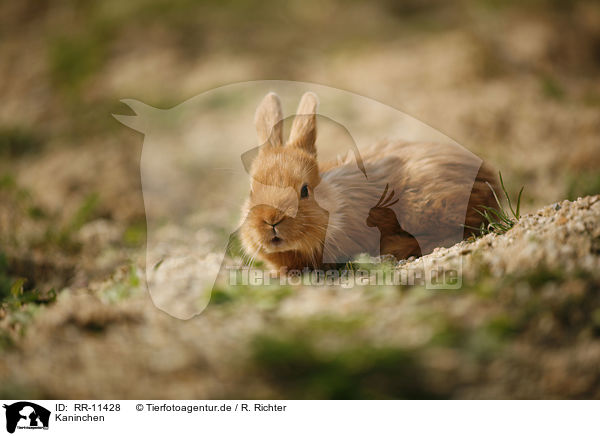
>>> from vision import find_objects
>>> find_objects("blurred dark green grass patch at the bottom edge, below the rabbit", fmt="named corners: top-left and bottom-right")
top-left (253, 333), bottom-right (436, 399)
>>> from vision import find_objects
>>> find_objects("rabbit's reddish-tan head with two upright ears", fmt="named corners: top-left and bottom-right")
top-left (240, 93), bottom-right (328, 261)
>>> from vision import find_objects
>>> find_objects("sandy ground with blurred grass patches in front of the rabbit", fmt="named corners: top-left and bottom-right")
top-left (1, 196), bottom-right (600, 398)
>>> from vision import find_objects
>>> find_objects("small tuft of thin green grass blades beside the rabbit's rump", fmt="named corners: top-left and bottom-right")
top-left (465, 172), bottom-right (525, 236)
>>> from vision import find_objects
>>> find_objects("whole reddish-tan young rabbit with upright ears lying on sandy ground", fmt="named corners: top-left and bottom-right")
top-left (239, 92), bottom-right (497, 270)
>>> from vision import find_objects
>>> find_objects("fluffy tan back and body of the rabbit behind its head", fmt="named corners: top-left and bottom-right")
top-left (321, 141), bottom-right (496, 254)
